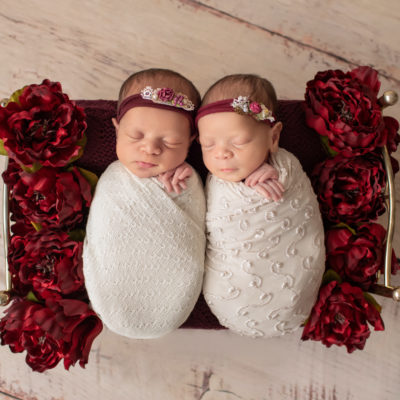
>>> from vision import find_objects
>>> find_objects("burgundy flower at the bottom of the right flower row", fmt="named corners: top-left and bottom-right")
top-left (302, 281), bottom-right (384, 353)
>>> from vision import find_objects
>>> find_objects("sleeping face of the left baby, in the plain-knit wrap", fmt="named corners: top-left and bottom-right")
top-left (113, 107), bottom-right (192, 178)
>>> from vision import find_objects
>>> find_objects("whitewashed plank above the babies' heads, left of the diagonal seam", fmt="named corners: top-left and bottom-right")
top-left (0, 0), bottom-right (400, 116)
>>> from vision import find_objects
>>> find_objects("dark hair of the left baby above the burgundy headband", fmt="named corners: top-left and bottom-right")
top-left (118, 68), bottom-right (201, 108)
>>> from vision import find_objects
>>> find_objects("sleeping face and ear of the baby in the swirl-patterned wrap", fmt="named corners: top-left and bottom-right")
top-left (198, 112), bottom-right (282, 182)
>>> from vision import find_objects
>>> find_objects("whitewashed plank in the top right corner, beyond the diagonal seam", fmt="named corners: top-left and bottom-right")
top-left (200, 0), bottom-right (400, 85)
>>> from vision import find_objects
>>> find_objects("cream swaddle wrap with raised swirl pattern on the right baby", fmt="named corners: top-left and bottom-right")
top-left (203, 149), bottom-right (325, 337)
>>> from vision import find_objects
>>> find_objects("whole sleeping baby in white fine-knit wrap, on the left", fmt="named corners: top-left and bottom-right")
top-left (83, 69), bottom-right (205, 338)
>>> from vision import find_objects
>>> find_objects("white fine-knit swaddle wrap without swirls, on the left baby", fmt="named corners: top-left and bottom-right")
top-left (83, 161), bottom-right (205, 339)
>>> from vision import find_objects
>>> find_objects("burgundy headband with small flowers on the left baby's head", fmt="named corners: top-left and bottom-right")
top-left (117, 86), bottom-right (195, 130)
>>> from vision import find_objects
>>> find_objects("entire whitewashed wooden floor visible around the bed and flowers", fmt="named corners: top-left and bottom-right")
top-left (0, 0), bottom-right (400, 400)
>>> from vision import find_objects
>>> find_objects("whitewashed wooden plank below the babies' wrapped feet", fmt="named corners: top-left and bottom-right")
top-left (0, 301), bottom-right (400, 400)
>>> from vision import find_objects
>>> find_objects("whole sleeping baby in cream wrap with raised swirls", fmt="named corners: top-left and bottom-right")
top-left (196, 75), bottom-right (325, 338)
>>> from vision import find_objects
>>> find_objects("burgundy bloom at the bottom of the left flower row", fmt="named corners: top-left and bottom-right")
top-left (0, 297), bottom-right (102, 372)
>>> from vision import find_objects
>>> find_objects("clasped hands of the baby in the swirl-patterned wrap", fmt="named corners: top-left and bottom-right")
top-left (244, 163), bottom-right (285, 201)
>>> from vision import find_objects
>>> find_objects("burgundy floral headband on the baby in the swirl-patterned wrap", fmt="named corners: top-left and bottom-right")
top-left (196, 96), bottom-right (276, 126)
